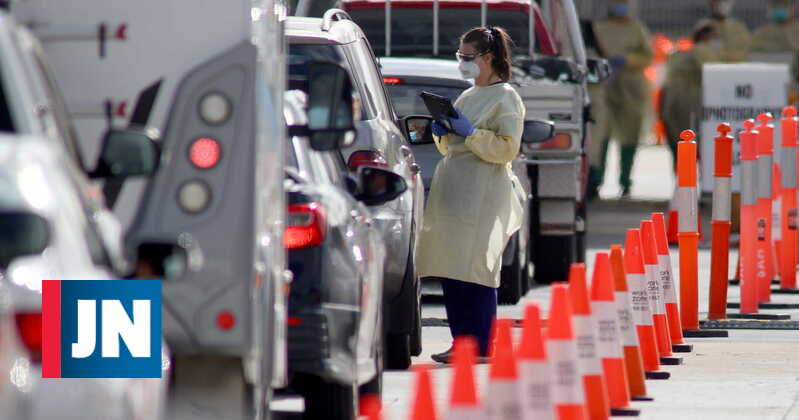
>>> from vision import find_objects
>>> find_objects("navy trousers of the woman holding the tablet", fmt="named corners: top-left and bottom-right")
top-left (437, 277), bottom-right (497, 356)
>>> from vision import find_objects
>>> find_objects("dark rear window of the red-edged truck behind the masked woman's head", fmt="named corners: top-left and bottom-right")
top-left (349, 7), bottom-right (538, 57)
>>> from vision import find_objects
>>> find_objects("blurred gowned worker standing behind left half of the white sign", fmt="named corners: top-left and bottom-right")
top-left (694, 0), bottom-right (752, 63)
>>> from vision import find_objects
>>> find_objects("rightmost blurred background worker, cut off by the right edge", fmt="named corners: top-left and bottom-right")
top-left (752, 0), bottom-right (799, 81)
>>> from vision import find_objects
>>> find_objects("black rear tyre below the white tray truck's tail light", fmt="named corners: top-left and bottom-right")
top-left (533, 234), bottom-right (577, 284)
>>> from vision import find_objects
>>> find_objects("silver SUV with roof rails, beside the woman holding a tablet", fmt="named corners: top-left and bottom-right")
top-left (286, 9), bottom-right (424, 369)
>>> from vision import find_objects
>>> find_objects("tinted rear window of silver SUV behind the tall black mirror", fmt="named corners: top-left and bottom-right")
top-left (288, 43), bottom-right (377, 120)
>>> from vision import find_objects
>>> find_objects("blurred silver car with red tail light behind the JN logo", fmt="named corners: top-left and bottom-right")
top-left (0, 135), bottom-right (169, 420)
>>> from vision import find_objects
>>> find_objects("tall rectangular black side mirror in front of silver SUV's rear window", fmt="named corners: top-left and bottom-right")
top-left (307, 62), bottom-right (355, 151)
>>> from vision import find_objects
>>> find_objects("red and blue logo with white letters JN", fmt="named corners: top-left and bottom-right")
top-left (42, 280), bottom-right (161, 378)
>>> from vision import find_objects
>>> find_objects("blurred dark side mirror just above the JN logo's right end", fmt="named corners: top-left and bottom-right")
top-left (133, 241), bottom-right (201, 280)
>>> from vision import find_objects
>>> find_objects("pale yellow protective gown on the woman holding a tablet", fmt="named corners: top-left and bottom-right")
top-left (416, 83), bottom-right (525, 288)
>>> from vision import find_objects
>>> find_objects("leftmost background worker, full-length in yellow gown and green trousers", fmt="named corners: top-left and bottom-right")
top-left (594, 0), bottom-right (652, 197)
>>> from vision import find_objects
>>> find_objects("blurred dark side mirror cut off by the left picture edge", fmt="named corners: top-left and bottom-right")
top-left (0, 210), bottom-right (50, 269)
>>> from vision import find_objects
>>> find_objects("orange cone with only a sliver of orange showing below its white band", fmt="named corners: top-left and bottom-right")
top-left (547, 283), bottom-right (588, 420)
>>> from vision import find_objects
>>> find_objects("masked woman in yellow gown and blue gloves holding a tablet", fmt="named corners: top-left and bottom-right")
top-left (416, 27), bottom-right (525, 363)
